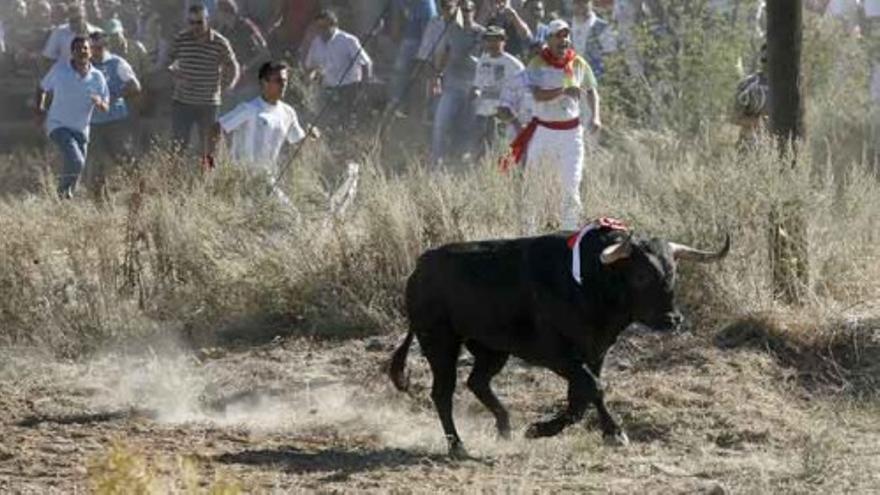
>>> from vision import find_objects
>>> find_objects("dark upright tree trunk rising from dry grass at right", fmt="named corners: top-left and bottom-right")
top-left (767, 0), bottom-right (809, 303)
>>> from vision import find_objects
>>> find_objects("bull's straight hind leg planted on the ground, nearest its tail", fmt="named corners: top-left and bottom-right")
top-left (419, 332), bottom-right (467, 458)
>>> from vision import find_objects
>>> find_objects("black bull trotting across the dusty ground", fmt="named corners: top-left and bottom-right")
top-left (389, 228), bottom-right (730, 456)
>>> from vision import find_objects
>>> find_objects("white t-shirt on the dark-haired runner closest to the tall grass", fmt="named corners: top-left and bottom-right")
top-left (219, 96), bottom-right (306, 173)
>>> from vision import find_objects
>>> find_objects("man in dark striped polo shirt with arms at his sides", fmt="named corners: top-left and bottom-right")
top-left (169, 5), bottom-right (239, 159)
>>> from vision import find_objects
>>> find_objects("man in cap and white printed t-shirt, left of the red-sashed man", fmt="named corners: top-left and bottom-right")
top-left (474, 26), bottom-right (525, 154)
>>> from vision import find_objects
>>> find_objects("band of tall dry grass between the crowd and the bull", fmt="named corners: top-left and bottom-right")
top-left (0, 121), bottom-right (880, 360)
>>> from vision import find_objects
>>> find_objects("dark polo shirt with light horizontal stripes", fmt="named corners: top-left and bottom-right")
top-left (171, 29), bottom-right (236, 105)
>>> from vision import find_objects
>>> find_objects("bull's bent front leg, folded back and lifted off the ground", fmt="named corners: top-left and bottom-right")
top-left (526, 362), bottom-right (602, 438)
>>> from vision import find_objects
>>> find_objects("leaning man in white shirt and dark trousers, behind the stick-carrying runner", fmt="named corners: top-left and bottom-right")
top-left (305, 10), bottom-right (373, 132)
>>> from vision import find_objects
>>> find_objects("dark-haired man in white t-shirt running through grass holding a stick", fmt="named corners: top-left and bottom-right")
top-left (207, 62), bottom-right (318, 204)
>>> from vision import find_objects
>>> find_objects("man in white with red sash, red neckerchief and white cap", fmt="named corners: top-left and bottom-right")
top-left (508, 19), bottom-right (602, 234)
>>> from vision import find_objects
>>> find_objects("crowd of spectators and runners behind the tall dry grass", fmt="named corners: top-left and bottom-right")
top-left (0, 0), bottom-right (880, 229)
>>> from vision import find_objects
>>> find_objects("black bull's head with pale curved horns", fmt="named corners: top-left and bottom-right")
top-left (600, 235), bottom-right (730, 330)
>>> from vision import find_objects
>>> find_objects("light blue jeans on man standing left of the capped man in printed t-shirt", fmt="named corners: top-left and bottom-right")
top-left (431, 86), bottom-right (476, 164)
